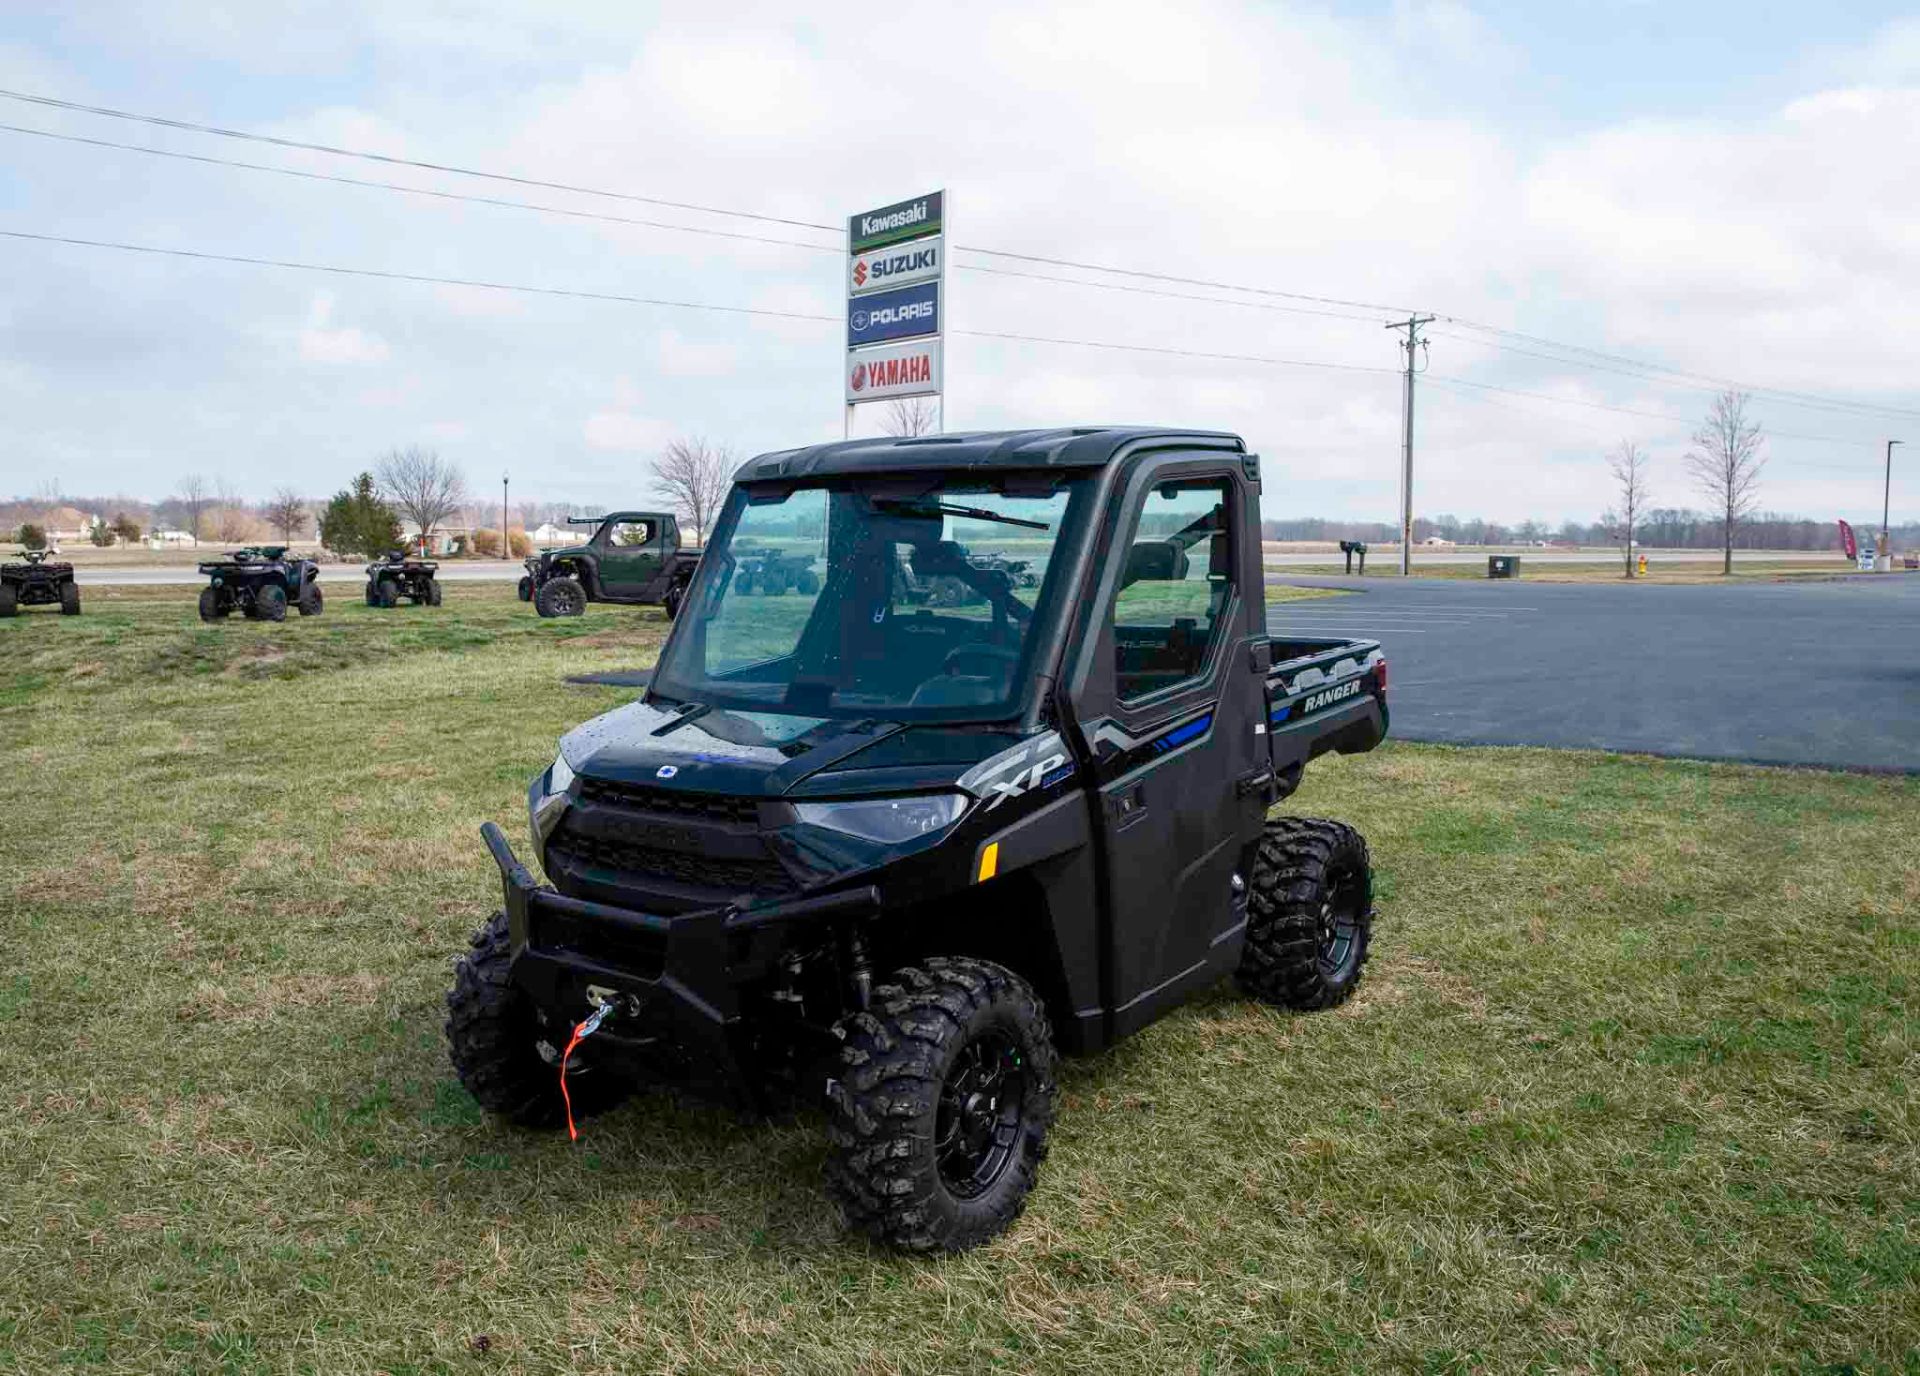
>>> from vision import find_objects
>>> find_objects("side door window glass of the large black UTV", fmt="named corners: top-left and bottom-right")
top-left (1114, 478), bottom-right (1233, 702)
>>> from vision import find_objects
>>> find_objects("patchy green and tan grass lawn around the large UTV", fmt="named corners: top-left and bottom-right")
top-left (0, 583), bottom-right (1920, 1376)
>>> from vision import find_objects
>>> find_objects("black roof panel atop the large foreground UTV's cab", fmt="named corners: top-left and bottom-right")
top-left (733, 426), bottom-right (1246, 482)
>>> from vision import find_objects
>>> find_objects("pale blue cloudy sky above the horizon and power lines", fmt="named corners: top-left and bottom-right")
top-left (0, 0), bottom-right (1920, 520)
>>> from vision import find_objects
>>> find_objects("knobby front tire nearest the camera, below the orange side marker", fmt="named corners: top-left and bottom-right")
top-left (828, 958), bottom-right (1056, 1251)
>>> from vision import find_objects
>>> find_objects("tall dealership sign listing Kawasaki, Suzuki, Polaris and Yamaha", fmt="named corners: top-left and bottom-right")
top-left (841, 192), bottom-right (947, 436)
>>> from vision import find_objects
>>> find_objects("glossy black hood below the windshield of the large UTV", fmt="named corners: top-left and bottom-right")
top-left (561, 702), bottom-right (1020, 798)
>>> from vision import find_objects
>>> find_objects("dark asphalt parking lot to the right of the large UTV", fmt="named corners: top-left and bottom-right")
top-left (1269, 576), bottom-right (1920, 771)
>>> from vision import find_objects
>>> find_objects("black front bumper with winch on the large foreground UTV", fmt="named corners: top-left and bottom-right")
top-left (480, 821), bottom-right (879, 1105)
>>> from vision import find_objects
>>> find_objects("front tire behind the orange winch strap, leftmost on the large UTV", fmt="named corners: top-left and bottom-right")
top-left (447, 912), bottom-right (632, 1128)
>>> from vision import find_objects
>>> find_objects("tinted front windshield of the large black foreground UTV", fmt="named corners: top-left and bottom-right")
top-left (653, 474), bottom-right (1087, 720)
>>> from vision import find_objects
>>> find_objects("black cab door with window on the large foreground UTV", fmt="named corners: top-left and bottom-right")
top-left (1073, 455), bottom-right (1271, 1036)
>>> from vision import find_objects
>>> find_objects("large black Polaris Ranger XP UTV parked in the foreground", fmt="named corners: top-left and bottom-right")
top-left (447, 430), bottom-right (1386, 1249)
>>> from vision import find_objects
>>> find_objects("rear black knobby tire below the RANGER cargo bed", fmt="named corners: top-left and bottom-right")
top-left (1236, 818), bottom-right (1373, 1011)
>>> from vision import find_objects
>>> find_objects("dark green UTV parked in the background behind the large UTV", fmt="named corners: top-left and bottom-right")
top-left (520, 510), bottom-right (701, 620)
